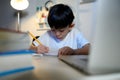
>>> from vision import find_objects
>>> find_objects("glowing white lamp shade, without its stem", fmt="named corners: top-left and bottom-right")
top-left (10, 0), bottom-right (29, 10)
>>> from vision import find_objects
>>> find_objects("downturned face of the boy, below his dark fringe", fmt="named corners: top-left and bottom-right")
top-left (51, 23), bottom-right (71, 40)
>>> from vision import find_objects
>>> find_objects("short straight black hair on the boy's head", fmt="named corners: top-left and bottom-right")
top-left (48, 4), bottom-right (74, 29)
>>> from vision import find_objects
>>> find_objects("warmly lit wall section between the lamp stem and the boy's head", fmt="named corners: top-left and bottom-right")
top-left (21, 0), bottom-right (49, 36)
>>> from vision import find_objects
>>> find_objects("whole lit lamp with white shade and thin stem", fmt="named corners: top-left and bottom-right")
top-left (10, 0), bottom-right (29, 31)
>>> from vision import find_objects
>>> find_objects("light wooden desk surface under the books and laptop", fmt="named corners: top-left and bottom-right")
top-left (0, 56), bottom-right (120, 80)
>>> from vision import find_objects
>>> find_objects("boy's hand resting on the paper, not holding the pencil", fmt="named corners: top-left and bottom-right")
top-left (58, 46), bottom-right (74, 55)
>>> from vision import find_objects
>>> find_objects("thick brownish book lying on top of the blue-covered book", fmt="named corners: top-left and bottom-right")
top-left (0, 29), bottom-right (31, 52)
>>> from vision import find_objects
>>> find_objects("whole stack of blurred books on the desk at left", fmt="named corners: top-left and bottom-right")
top-left (0, 29), bottom-right (34, 77)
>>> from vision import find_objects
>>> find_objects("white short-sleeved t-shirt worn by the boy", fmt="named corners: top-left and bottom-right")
top-left (33, 28), bottom-right (89, 55)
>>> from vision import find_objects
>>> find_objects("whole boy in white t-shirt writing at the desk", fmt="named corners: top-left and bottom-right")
top-left (31, 4), bottom-right (90, 55)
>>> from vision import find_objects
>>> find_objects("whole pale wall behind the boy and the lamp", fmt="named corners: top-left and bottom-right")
top-left (0, 0), bottom-right (95, 42)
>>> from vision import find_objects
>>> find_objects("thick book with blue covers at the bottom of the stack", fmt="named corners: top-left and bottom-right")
top-left (0, 50), bottom-right (35, 77)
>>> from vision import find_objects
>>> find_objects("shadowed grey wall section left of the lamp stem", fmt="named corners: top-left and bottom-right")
top-left (0, 0), bottom-right (17, 30)
